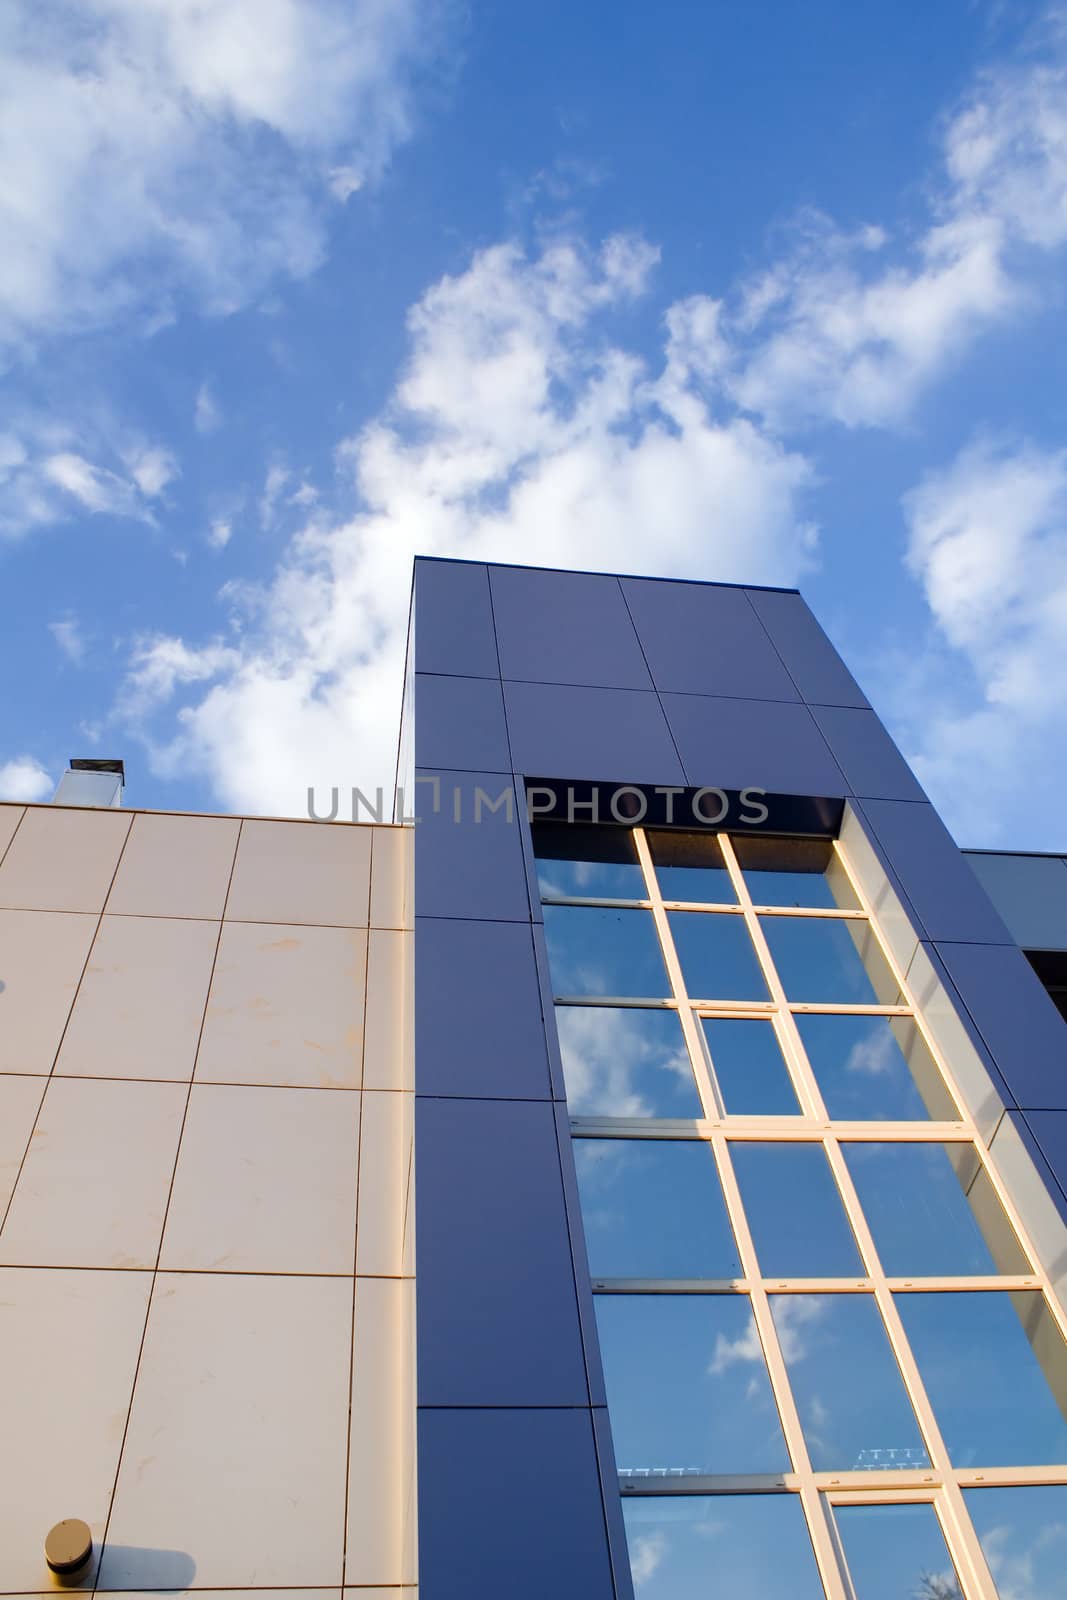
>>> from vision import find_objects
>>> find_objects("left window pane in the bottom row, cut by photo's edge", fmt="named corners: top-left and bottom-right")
top-left (622, 1494), bottom-right (822, 1600)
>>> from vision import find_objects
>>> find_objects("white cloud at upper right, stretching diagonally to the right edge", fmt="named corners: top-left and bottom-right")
top-left (726, 28), bottom-right (1067, 429)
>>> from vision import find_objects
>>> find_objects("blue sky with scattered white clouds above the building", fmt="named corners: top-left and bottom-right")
top-left (0, 0), bottom-right (1067, 850)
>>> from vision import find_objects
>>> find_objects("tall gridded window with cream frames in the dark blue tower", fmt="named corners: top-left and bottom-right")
top-left (534, 824), bottom-right (1067, 1600)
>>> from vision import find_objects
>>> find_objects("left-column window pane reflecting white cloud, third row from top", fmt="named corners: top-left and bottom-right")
top-left (555, 1005), bottom-right (704, 1117)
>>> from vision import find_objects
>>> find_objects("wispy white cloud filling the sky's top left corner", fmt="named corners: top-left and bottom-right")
top-left (0, 0), bottom-right (446, 346)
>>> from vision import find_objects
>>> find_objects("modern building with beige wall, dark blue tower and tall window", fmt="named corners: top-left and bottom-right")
top-left (0, 560), bottom-right (1067, 1600)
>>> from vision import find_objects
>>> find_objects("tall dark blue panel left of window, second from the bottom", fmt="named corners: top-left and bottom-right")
top-left (416, 1100), bottom-right (589, 1406)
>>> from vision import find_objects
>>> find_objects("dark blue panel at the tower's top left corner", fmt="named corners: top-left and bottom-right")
top-left (413, 558), bottom-right (501, 678)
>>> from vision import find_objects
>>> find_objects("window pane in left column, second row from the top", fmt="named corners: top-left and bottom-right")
top-left (544, 906), bottom-right (670, 1000)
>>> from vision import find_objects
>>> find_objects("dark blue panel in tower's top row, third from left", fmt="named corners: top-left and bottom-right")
top-left (622, 578), bottom-right (800, 701)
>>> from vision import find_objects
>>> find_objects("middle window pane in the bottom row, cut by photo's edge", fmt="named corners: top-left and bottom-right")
top-left (833, 1504), bottom-right (963, 1600)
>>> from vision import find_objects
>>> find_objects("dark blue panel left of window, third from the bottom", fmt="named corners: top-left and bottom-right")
top-left (414, 917), bottom-right (552, 1099)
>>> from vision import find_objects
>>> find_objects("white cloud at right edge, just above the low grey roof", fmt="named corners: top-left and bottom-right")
top-left (899, 440), bottom-right (1067, 843)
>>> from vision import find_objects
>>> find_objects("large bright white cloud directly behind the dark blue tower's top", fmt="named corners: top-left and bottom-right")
top-left (115, 235), bottom-right (814, 813)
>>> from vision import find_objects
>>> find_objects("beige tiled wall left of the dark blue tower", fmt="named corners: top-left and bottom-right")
top-left (0, 805), bottom-right (416, 1600)
